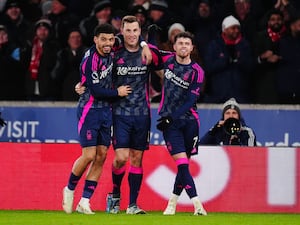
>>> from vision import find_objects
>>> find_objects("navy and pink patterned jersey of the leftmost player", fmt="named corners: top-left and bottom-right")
top-left (79, 46), bottom-right (113, 108)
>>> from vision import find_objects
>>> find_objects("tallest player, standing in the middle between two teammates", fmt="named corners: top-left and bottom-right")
top-left (110, 16), bottom-right (162, 214)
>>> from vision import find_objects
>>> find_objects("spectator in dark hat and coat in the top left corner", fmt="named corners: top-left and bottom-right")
top-left (1, 0), bottom-right (32, 47)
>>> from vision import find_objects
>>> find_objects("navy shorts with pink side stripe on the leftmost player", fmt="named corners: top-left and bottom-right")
top-left (77, 107), bottom-right (112, 147)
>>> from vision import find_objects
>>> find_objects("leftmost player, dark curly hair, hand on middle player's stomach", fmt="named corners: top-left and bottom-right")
top-left (62, 24), bottom-right (131, 214)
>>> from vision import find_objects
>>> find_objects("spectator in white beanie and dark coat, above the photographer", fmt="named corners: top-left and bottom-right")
top-left (204, 16), bottom-right (254, 103)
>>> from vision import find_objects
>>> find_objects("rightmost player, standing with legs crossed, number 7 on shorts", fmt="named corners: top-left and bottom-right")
top-left (157, 32), bottom-right (207, 215)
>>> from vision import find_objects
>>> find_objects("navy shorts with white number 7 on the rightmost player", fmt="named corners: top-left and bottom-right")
top-left (163, 119), bottom-right (199, 157)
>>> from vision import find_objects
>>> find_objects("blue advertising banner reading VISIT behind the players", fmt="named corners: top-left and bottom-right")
top-left (0, 103), bottom-right (300, 147)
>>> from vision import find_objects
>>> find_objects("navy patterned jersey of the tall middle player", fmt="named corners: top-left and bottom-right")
top-left (113, 47), bottom-right (163, 116)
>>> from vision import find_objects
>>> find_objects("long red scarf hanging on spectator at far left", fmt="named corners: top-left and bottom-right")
top-left (29, 37), bottom-right (43, 80)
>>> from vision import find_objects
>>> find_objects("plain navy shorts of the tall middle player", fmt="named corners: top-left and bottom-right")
top-left (113, 115), bottom-right (150, 150)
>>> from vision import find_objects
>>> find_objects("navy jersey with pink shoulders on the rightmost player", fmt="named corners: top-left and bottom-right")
top-left (158, 53), bottom-right (204, 119)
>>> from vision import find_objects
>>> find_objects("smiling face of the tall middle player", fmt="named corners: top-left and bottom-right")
top-left (121, 17), bottom-right (141, 50)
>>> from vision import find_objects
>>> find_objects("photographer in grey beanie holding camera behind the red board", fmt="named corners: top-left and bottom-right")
top-left (200, 98), bottom-right (256, 146)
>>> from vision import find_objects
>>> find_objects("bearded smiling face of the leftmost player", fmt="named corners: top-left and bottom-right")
top-left (94, 33), bottom-right (115, 56)
